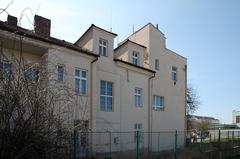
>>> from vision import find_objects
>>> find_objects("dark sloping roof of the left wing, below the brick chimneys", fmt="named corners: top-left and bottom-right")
top-left (0, 21), bottom-right (99, 57)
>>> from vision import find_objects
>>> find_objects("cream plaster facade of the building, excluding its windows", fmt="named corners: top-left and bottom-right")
top-left (0, 16), bottom-right (187, 152)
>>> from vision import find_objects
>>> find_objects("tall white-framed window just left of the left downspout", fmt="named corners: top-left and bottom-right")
top-left (75, 68), bottom-right (87, 95)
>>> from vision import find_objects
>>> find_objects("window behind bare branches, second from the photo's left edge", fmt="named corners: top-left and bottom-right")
top-left (24, 66), bottom-right (39, 81)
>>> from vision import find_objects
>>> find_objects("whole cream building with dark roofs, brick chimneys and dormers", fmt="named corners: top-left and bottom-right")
top-left (0, 15), bottom-right (187, 151)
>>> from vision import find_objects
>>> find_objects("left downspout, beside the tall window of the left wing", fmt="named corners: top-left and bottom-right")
top-left (89, 56), bottom-right (99, 131)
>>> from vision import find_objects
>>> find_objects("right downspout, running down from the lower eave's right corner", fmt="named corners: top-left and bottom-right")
top-left (148, 73), bottom-right (155, 152)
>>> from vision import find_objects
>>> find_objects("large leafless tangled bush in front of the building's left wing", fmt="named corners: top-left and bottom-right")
top-left (0, 42), bottom-right (88, 159)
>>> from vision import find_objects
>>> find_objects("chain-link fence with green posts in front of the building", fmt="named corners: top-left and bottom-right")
top-left (72, 130), bottom-right (240, 159)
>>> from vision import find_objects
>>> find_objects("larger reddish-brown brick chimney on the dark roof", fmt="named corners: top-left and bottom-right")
top-left (34, 15), bottom-right (51, 37)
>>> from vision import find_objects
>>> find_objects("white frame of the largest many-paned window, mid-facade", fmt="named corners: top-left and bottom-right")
top-left (99, 80), bottom-right (114, 111)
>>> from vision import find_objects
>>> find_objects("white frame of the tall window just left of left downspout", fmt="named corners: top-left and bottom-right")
top-left (74, 68), bottom-right (88, 95)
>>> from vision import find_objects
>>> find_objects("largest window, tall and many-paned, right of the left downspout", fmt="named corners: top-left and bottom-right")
top-left (100, 81), bottom-right (113, 111)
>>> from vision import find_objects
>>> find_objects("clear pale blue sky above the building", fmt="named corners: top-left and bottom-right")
top-left (0, 0), bottom-right (240, 123)
